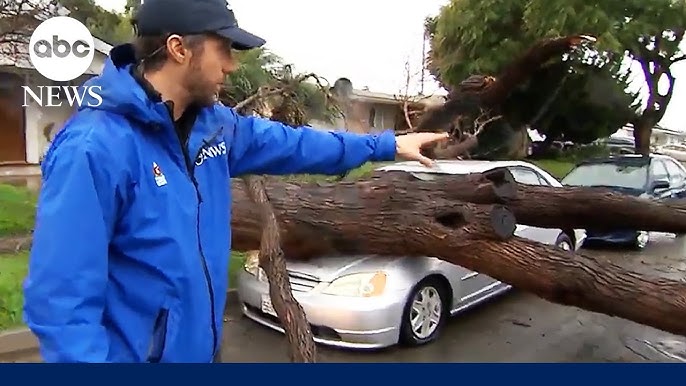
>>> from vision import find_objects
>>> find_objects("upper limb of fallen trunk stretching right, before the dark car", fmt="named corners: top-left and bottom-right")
top-left (374, 169), bottom-right (686, 234)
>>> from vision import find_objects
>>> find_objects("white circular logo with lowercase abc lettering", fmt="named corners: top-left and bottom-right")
top-left (29, 16), bottom-right (95, 82)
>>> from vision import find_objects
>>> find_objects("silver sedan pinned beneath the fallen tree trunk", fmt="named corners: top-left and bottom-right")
top-left (238, 161), bottom-right (586, 349)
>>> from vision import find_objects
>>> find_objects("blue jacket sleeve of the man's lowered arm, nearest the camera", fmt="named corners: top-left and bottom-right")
top-left (24, 131), bottom-right (124, 362)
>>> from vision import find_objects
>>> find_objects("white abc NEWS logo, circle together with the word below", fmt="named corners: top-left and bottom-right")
top-left (22, 16), bottom-right (102, 107)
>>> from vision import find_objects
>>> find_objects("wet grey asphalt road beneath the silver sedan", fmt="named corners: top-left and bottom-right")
top-left (223, 234), bottom-right (686, 362)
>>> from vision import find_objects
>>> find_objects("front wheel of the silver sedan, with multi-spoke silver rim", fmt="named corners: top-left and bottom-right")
top-left (400, 278), bottom-right (449, 346)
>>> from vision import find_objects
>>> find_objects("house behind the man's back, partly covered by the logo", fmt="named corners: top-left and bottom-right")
top-left (0, 12), bottom-right (112, 165)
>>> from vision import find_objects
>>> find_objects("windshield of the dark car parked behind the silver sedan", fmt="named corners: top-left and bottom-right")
top-left (562, 162), bottom-right (648, 189)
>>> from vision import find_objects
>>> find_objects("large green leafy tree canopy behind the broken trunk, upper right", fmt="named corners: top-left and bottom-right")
top-left (426, 0), bottom-right (686, 152)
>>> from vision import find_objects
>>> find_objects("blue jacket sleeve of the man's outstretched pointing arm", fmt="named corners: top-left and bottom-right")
top-left (227, 109), bottom-right (396, 177)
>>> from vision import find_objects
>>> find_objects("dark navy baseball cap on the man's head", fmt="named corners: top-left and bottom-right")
top-left (133, 0), bottom-right (265, 50)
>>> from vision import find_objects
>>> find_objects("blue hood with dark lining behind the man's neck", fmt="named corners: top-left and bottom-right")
top-left (79, 44), bottom-right (168, 124)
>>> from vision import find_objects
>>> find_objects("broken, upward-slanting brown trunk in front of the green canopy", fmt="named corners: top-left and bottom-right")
top-left (417, 35), bottom-right (595, 158)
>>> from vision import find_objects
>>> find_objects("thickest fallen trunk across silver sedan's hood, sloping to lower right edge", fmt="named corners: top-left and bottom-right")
top-left (231, 173), bottom-right (686, 335)
